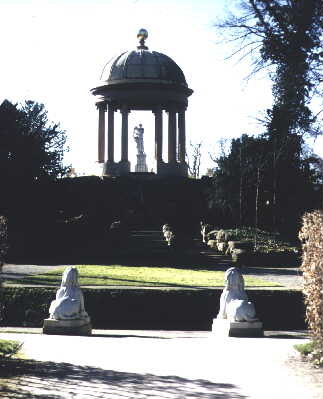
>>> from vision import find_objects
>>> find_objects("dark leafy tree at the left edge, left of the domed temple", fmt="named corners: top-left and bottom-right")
top-left (0, 100), bottom-right (67, 182)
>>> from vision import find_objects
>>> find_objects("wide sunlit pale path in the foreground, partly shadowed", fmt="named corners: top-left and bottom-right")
top-left (0, 330), bottom-right (323, 399)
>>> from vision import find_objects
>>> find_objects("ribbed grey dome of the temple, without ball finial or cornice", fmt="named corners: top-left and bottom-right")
top-left (101, 46), bottom-right (187, 87)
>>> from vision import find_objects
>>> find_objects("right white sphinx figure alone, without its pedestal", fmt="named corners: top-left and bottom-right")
top-left (217, 267), bottom-right (258, 322)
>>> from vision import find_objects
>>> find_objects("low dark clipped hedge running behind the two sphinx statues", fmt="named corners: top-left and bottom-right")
top-left (0, 287), bottom-right (306, 330)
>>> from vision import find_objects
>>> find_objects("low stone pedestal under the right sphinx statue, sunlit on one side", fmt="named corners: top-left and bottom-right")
top-left (212, 319), bottom-right (264, 337)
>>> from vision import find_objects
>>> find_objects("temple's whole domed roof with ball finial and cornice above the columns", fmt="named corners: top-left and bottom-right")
top-left (91, 29), bottom-right (193, 110)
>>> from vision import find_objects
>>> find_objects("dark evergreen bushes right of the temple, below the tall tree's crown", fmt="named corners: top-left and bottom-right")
top-left (209, 134), bottom-right (322, 234)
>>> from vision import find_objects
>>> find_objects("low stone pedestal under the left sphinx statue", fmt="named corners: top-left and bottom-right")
top-left (43, 317), bottom-right (92, 335)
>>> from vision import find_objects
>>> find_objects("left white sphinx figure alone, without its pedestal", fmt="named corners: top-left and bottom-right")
top-left (49, 266), bottom-right (89, 320)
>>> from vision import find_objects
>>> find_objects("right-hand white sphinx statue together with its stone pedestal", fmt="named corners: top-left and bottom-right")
top-left (212, 267), bottom-right (263, 336)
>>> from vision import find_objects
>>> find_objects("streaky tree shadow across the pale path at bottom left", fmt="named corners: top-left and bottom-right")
top-left (0, 360), bottom-right (246, 399)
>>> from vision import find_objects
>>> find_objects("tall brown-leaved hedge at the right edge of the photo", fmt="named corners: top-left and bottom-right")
top-left (299, 210), bottom-right (323, 365)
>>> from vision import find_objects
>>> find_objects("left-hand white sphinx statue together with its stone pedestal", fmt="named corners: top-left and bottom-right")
top-left (43, 266), bottom-right (91, 335)
